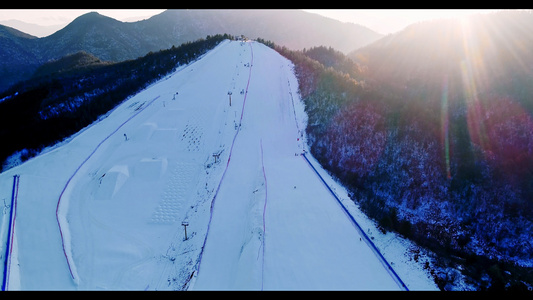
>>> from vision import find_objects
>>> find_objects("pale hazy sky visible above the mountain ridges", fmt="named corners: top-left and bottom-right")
top-left (0, 9), bottom-right (502, 34)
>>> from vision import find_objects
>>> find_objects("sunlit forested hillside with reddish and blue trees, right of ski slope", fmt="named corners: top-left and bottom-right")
top-left (264, 12), bottom-right (533, 289)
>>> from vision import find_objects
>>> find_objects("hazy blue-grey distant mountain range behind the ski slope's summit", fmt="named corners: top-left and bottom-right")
top-left (0, 9), bottom-right (382, 91)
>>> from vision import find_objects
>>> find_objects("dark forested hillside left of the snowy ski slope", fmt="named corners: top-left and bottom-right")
top-left (0, 35), bottom-right (231, 167)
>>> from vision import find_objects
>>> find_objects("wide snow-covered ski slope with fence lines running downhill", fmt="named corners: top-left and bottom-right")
top-left (0, 41), bottom-right (436, 290)
